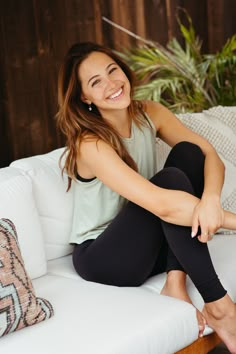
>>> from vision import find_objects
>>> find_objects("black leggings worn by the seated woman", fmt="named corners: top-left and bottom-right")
top-left (73, 142), bottom-right (226, 302)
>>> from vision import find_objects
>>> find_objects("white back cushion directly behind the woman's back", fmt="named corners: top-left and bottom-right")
top-left (11, 148), bottom-right (73, 260)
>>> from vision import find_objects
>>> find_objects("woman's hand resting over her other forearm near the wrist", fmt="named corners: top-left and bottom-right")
top-left (192, 196), bottom-right (224, 242)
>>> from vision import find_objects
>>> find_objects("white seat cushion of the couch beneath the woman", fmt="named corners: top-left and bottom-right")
top-left (1, 275), bottom-right (198, 354)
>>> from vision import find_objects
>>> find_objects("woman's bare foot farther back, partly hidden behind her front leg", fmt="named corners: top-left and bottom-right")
top-left (161, 274), bottom-right (206, 337)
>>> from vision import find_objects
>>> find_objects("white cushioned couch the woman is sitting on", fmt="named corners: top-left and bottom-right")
top-left (0, 106), bottom-right (236, 354)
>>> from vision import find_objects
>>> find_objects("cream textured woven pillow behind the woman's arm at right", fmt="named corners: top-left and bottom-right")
top-left (177, 106), bottom-right (236, 233)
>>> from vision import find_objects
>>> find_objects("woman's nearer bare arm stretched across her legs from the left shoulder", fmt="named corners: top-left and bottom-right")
top-left (80, 140), bottom-right (236, 238)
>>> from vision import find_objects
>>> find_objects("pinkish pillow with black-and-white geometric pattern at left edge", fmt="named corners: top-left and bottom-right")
top-left (0, 219), bottom-right (53, 337)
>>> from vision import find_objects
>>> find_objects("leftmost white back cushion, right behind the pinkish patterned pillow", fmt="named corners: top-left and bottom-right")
top-left (0, 167), bottom-right (47, 279)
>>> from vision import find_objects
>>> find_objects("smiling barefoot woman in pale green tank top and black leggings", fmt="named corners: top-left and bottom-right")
top-left (57, 43), bottom-right (236, 353)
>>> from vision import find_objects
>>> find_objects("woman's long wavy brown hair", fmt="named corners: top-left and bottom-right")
top-left (56, 42), bottom-right (147, 190)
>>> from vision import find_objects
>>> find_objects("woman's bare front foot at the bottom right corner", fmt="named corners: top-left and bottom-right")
top-left (203, 294), bottom-right (236, 354)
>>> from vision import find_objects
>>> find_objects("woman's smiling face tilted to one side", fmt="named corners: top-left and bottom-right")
top-left (78, 52), bottom-right (130, 114)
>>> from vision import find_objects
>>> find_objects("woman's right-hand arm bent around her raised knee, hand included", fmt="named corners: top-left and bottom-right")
top-left (146, 102), bottom-right (224, 241)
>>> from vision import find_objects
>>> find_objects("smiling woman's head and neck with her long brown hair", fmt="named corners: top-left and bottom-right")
top-left (57, 43), bottom-right (147, 186)
